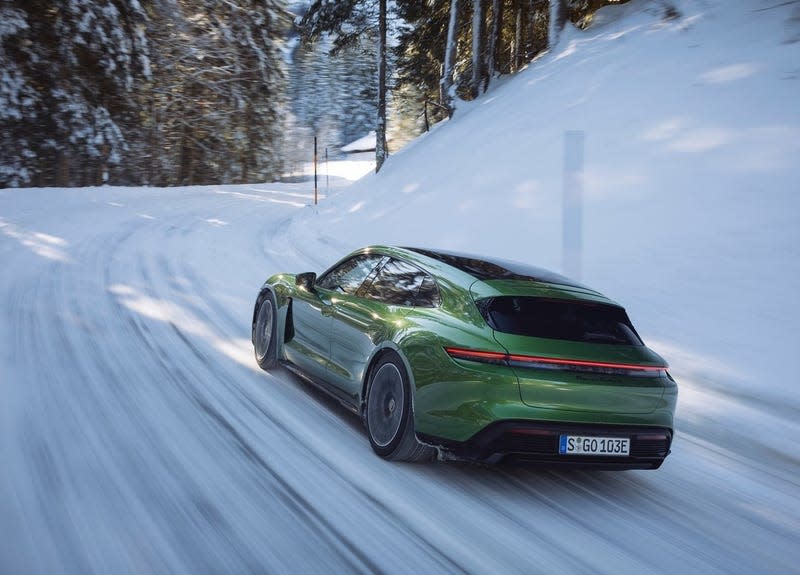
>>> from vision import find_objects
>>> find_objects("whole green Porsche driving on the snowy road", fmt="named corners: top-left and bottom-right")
top-left (252, 246), bottom-right (678, 469)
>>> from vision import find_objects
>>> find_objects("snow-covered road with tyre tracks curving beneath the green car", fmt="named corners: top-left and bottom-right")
top-left (0, 185), bottom-right (800, 574)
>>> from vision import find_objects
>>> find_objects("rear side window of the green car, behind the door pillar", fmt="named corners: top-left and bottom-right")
top-left (365, 259), bottom-right (439, 307)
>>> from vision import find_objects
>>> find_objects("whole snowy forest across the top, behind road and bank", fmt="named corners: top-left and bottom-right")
top-left (0, 0), bottom-right (636, 187)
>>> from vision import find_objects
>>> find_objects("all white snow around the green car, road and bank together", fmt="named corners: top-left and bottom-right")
top-left (0, 0), bottom-right (800, 574)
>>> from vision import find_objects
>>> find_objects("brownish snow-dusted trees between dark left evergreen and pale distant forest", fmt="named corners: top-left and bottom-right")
top-left (148, 0), bottom-right (289, 184)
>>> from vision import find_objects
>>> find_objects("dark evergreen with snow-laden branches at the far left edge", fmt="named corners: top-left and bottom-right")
top-left (0, 0), bottom-right (150, 186)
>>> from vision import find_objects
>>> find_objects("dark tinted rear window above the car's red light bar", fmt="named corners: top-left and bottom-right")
top-left (477, 296), bottom-right (643, 345)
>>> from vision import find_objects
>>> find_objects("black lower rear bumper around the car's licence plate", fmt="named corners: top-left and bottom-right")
top-left (419, 420), bottom-right (672, 469)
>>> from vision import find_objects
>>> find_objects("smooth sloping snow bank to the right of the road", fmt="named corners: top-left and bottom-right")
top-left (295, 0), bottom-right (800, 408)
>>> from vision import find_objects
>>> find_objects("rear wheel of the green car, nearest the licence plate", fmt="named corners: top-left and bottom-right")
top-left (364, 352), bottom-right (434, 461)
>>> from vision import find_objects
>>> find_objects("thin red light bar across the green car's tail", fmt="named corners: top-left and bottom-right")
top-left (444, 347), bottom-right (667, 377)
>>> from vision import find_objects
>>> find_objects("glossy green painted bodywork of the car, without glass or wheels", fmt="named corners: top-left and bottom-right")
top-left (254, 246), bottom-right (677, 467)
